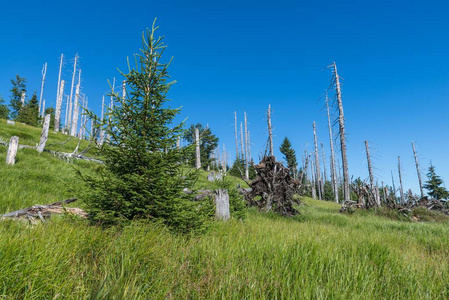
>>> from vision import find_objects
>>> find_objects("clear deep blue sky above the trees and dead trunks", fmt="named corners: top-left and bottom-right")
top-left (0, 0), bottom-right (449, 193)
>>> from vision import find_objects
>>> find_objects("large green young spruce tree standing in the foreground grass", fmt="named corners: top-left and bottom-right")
top-left (82, 24), bottom-right (211, 233)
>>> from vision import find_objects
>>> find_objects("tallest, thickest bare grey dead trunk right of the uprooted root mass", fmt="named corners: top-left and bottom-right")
top-left (333, 62), bottom-right (350, 201)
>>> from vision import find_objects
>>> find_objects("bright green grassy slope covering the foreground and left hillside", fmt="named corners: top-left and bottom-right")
top-left (0, 119), bottom-right (449, 299)
